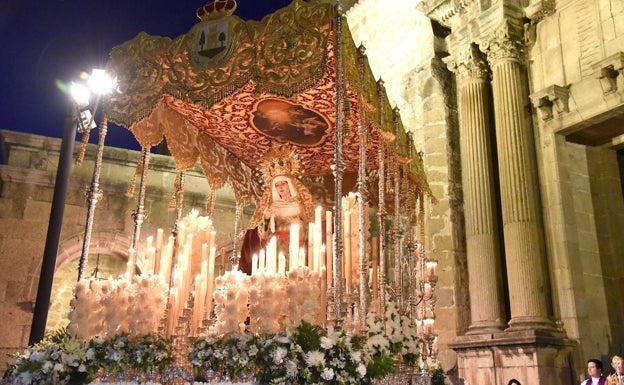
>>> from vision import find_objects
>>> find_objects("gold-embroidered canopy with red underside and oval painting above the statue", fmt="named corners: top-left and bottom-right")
top-left (106, 0), bottom-right (429, 207)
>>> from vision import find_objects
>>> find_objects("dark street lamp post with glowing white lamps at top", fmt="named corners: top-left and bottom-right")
top-left (28, 70), bottom-right (114, 345)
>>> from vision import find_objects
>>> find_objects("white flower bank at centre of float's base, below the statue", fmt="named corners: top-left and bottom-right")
top-left (188, 321), bottom-right (402, 385)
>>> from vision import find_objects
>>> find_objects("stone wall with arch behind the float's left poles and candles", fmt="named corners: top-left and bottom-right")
top-left (0, 130), bottom-right (243, 372)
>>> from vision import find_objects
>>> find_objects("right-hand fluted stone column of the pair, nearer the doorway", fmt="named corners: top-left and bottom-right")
top-left (481, 34), bottom-right (553, 329)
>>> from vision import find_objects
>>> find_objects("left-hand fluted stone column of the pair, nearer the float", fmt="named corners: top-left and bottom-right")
top-left (447, 46), bottom-right (505, 334)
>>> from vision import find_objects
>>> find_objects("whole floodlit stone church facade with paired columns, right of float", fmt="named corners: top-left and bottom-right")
top-left (348, 0), bottom-right (624, 385)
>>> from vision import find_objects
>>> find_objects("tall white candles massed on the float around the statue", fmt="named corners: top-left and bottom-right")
top-left (126, 195), bottom-right (386, 336)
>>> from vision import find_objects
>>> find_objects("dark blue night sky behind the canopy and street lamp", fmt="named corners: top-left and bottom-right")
top-left (0, 0), bottom-right (290, 149)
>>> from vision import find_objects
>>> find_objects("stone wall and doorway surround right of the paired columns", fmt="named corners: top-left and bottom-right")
top-left (527, 0), bottom-right (624, 362)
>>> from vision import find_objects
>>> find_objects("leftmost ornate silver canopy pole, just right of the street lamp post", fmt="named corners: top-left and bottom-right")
top-left (78, 111), bottom-right (108, 281)
